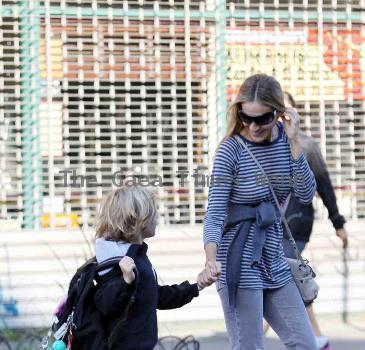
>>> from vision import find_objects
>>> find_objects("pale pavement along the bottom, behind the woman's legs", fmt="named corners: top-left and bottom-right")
top-left (159, 314), bottom-right (365, 350)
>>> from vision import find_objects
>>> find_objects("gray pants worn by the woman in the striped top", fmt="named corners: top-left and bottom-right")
top-left (217, 282), bottom-right (317, 350)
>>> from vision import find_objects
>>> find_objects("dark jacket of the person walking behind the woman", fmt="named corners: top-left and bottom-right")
top-left (284, 132), bottom-right (346, 242)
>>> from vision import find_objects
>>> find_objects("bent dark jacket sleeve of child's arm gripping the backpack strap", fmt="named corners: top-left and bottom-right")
top-left (94, 277), bottom-right (134, 316)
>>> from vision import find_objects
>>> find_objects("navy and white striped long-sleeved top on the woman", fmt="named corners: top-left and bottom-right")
top-left (204, 122), bottom-right (316, 289)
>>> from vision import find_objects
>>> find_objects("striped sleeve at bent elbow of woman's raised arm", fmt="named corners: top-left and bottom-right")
top-left (291, 153), bottom-right (317, 204)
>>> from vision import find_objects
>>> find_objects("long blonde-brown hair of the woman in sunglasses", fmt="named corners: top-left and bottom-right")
top-left (222, 74), bottom-right (285, 142)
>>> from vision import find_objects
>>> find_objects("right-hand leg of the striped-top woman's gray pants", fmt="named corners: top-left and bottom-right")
top-left (264, 281), bottom-right (317, 350)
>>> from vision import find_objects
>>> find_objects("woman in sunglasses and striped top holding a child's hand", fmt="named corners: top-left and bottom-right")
top-left (200, 74), bottom-right (316, 350)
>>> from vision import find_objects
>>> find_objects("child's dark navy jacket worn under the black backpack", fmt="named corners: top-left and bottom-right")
top-left (90, 241), bottom-right (199, 350)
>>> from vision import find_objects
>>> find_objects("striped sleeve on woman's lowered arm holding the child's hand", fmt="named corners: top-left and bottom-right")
top-left (204, 139), bottom-right (239, 246)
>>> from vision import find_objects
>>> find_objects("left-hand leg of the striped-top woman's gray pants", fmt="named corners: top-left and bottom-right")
top-left (217, 284), bottom-right (264, 350)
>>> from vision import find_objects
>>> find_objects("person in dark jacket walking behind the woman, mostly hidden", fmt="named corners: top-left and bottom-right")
top-left (272, 92), bottom-right (348, 350)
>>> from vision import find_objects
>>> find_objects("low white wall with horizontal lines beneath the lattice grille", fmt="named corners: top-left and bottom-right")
top-left (0, 220), bottom-right (365, 330)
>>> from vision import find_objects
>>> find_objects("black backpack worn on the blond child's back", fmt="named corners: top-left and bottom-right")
top-left (43, 257), bottom-right (138, 350)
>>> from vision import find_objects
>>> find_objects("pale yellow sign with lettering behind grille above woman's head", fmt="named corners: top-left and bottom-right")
top-left (226, 30), bottom-right (345, 101)
